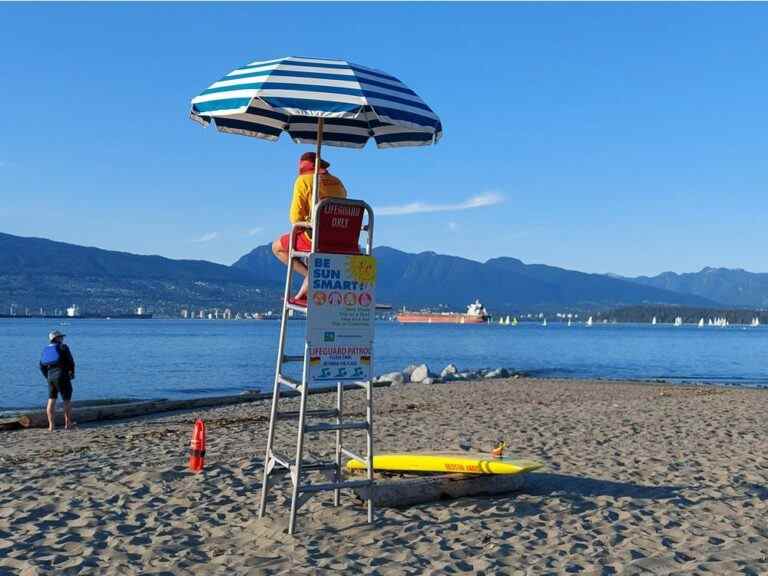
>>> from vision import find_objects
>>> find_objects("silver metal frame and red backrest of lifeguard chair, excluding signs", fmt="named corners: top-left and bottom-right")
top-left (259, 198), bottom-right (374, 534)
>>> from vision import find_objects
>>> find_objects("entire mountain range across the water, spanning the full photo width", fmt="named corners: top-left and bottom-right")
top-left (0, 234), bottom-right (768, 316)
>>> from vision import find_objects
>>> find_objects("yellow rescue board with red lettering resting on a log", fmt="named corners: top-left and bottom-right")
top-left (347, 452), bottom-right (543, 474)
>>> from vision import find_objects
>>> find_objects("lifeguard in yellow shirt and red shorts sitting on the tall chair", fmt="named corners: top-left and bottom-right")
top-left (272, 152), bottom-right (347, 306)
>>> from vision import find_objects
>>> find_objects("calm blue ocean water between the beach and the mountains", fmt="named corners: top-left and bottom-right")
top-left (0, 319), bottom-right (768, 409)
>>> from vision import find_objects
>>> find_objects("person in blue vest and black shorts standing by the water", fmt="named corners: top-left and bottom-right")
top-left (40, 330), bottom-right (75, 432)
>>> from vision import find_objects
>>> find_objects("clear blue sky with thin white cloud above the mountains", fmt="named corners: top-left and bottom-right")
top-left (0, 3), bottom-right (768, 275)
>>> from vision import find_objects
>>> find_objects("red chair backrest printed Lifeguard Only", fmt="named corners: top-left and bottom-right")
top-left (314, 198), bottom-right (367, 254)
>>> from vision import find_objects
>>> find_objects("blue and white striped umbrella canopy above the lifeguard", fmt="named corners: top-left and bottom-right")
top-left (191, 57), bottom-right (443, 148)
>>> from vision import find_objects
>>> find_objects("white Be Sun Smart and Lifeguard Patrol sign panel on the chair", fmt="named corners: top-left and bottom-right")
top-left (306, 253), bottom-right (376, 384)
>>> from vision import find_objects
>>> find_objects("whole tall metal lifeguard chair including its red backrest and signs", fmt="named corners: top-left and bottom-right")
top-left (259, 198), bottom-right (375, 534)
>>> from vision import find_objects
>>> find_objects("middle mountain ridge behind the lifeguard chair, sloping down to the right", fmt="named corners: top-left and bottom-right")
top-left (233, 245), bottom-right (716, 313)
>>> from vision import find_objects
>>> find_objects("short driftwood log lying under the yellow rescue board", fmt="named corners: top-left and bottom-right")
top-left (354, 473), bottom-right (529, 508)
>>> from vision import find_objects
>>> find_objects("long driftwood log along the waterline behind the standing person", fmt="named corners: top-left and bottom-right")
top-left (14, 382), bottom-right (390, 430)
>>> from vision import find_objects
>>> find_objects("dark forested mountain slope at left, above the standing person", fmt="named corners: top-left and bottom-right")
top-left (0, 234), bottom-right (279, 315)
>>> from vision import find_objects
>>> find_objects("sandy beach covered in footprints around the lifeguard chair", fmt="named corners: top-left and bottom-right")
top-left (0, 378), bottom-right (768, 575)
